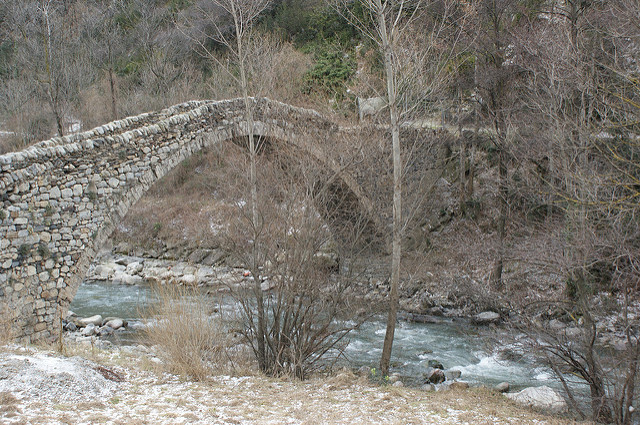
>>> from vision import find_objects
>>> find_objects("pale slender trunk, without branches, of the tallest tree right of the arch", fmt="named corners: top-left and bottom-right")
top-left (376, 0), bottom-right (402, 376)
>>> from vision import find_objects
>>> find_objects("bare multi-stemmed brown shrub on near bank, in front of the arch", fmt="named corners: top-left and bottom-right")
top-left (220, 142), bottom-right (370, 379)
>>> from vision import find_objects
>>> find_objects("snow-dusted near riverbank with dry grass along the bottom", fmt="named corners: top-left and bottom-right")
top-left (0, 344), bottom-right (574, 425)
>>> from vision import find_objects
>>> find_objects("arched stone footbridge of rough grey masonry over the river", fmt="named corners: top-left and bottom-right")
top-left (0, 99), bottom-right (376, 342)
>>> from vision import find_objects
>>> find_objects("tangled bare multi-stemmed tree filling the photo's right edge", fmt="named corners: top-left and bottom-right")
top-left (521, 0), bottom-right (640, 424)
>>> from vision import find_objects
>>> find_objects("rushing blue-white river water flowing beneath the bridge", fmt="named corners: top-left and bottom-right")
top-left (70, 283), bottom-right (552, 388)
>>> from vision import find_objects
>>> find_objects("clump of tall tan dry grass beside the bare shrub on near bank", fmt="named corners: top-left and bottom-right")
top-left (145, 284), bottom-right (244, 381)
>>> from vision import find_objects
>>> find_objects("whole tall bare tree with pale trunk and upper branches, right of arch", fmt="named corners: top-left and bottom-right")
top-left (332, 0), bottom-right (468, 375)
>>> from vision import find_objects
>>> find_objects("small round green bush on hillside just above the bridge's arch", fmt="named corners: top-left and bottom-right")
top-left (304, 45), bottom-right (356, 100)
